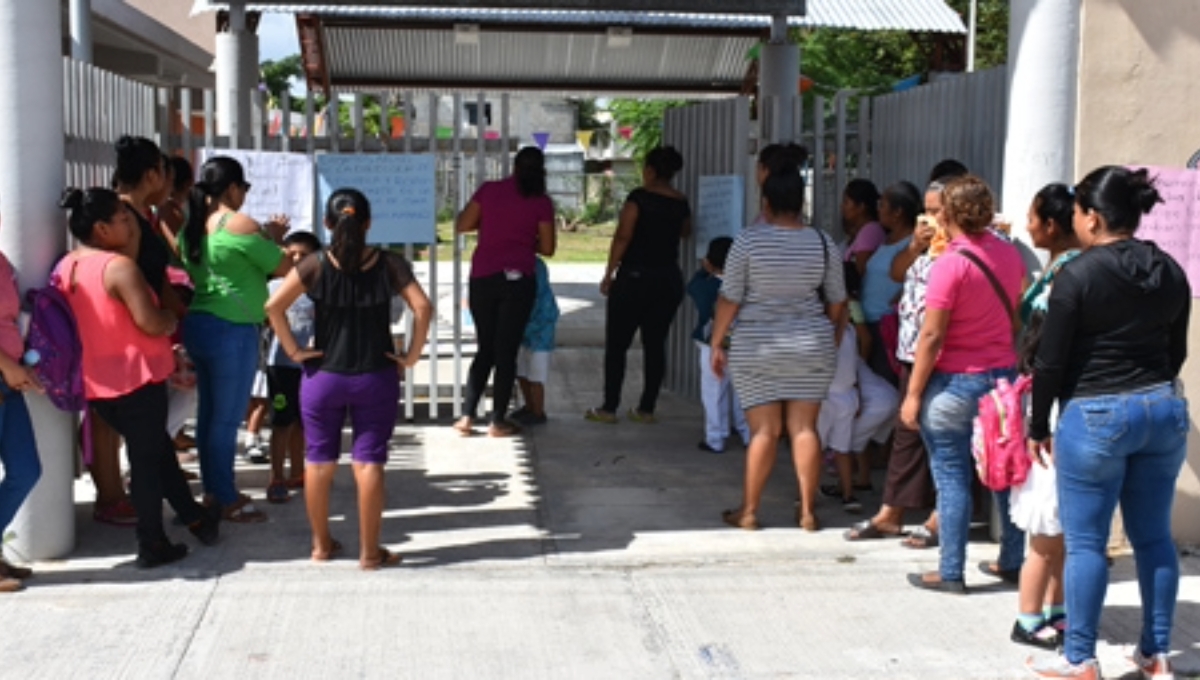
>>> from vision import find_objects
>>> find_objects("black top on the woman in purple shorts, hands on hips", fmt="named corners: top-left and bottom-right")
top-left (296, 251), bottom-right (415, 375)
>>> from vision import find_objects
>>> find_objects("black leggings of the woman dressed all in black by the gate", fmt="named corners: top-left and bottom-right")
top-left (601, 270), bottom-right (683, 414)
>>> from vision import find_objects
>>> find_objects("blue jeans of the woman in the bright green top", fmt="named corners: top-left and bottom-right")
top-left (184, 312), bottom-right (258, 506)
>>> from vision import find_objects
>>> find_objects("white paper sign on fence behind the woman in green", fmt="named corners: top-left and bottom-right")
top-left (197, 148), bottom-right (313, 231)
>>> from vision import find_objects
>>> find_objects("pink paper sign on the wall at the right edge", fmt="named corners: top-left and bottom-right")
top-left (1138, 167), bottom-right (1200, 296)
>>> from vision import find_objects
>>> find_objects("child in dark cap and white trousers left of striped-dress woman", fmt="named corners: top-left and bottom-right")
top-left (688, 236), bottom-right (750, 453)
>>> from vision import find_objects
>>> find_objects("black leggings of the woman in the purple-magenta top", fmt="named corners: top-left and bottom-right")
top-left (463, 273), bottom-right (538, 423)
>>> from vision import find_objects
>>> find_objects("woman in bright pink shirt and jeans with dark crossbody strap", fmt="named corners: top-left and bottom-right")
top-left (900, 175), bottom-right (1025, 594)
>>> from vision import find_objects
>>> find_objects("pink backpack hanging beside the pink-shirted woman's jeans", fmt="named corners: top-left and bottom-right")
top-left (971, 375), bottom-right (1033, 491)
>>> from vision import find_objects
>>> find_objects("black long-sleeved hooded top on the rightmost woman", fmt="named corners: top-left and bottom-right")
top-left (1028, 239), bottom-right (1192, 440)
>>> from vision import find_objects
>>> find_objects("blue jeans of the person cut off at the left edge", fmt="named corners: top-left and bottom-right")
top-left (0, 379), bottom-right (42, 534)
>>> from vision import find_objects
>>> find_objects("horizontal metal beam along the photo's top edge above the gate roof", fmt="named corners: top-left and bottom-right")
top-left (240, 0), bottom-right (806, 17)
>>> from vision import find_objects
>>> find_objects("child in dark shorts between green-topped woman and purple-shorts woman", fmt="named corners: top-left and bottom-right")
top-left (266, 231), bottom-right (320, 503)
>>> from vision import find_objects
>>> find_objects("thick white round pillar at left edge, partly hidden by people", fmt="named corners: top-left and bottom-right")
top-left (0, 0), bottom-right (76, 560)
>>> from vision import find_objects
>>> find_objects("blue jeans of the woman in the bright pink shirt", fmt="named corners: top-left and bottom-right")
top-left (920, 368), bottom-right (1025, 580)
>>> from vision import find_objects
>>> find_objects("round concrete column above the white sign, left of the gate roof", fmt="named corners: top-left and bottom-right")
top-left (216, 0), bottom-right (258, 148)
